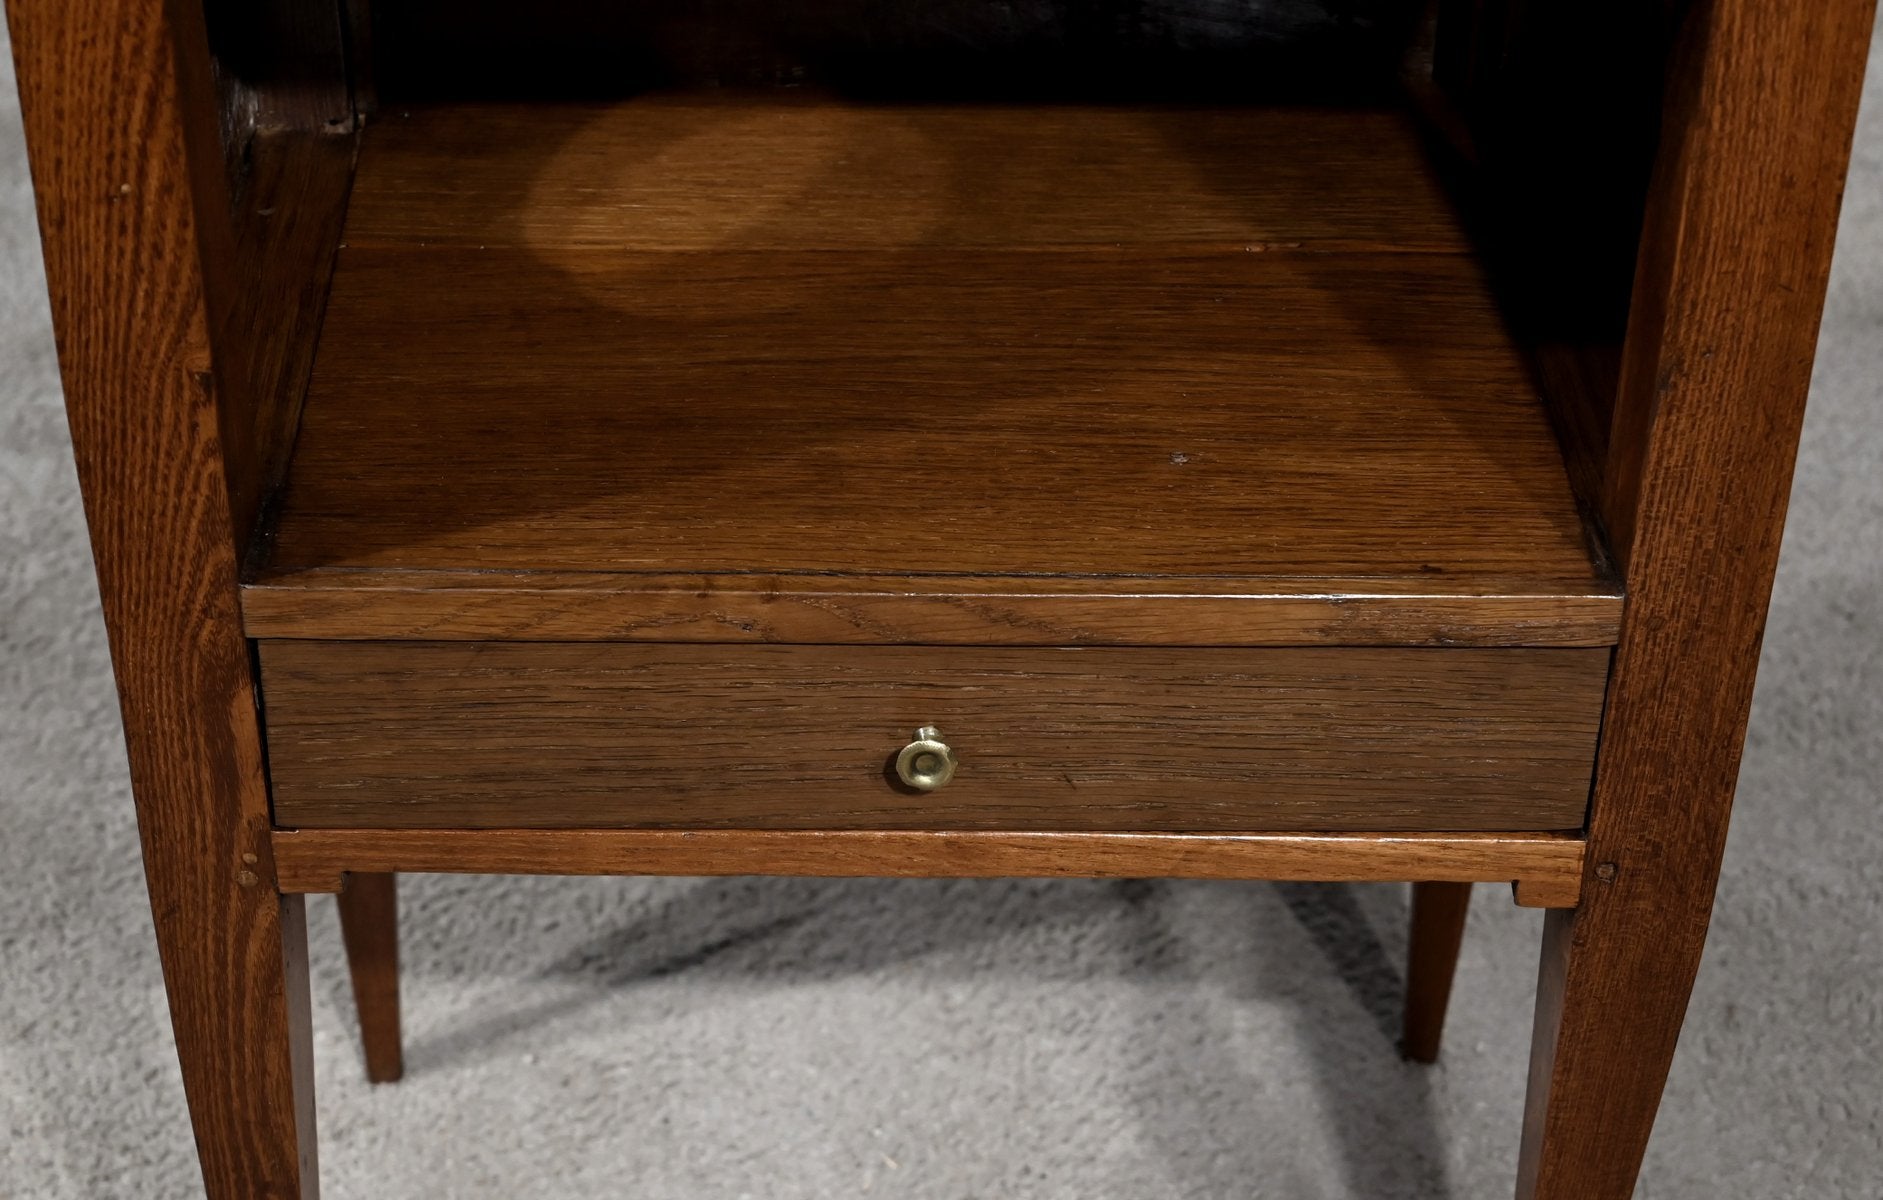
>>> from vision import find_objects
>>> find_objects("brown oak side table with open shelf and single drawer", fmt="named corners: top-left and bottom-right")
top-left (8, 0), bottom-right (1872, 1200)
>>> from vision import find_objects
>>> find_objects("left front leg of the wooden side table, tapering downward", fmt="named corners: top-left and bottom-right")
top-left (6, 0), bottom-right (316, 1200)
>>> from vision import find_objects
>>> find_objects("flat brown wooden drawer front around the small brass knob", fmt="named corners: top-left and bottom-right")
top-left (262, 641), bottom-right (1608, 831)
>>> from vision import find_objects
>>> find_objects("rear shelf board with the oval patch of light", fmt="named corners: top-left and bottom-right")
top-left (346, 101), bottom-right (1471, 252)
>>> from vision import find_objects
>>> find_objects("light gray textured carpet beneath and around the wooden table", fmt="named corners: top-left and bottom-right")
top-left (0, 18), bottom-right (1883, 1200)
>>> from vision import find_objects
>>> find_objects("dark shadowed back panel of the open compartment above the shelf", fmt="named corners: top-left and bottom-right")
top-left (375, 0), bottom-right (1414, 102)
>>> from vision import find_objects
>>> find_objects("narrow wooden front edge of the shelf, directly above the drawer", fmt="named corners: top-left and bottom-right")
top-left (243, 569), bottom-right (1621, 646)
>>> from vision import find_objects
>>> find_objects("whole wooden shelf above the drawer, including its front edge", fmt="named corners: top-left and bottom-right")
top-left (245, 98), bottom-right (1619, 644)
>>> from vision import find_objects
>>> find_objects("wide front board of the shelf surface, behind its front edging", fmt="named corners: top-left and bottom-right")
top-left (269, 251), bottom-right (1595, 586)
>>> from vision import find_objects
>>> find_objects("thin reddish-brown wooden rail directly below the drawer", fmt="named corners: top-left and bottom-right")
top-left (275, 829), bottom-right (1582, 908)
